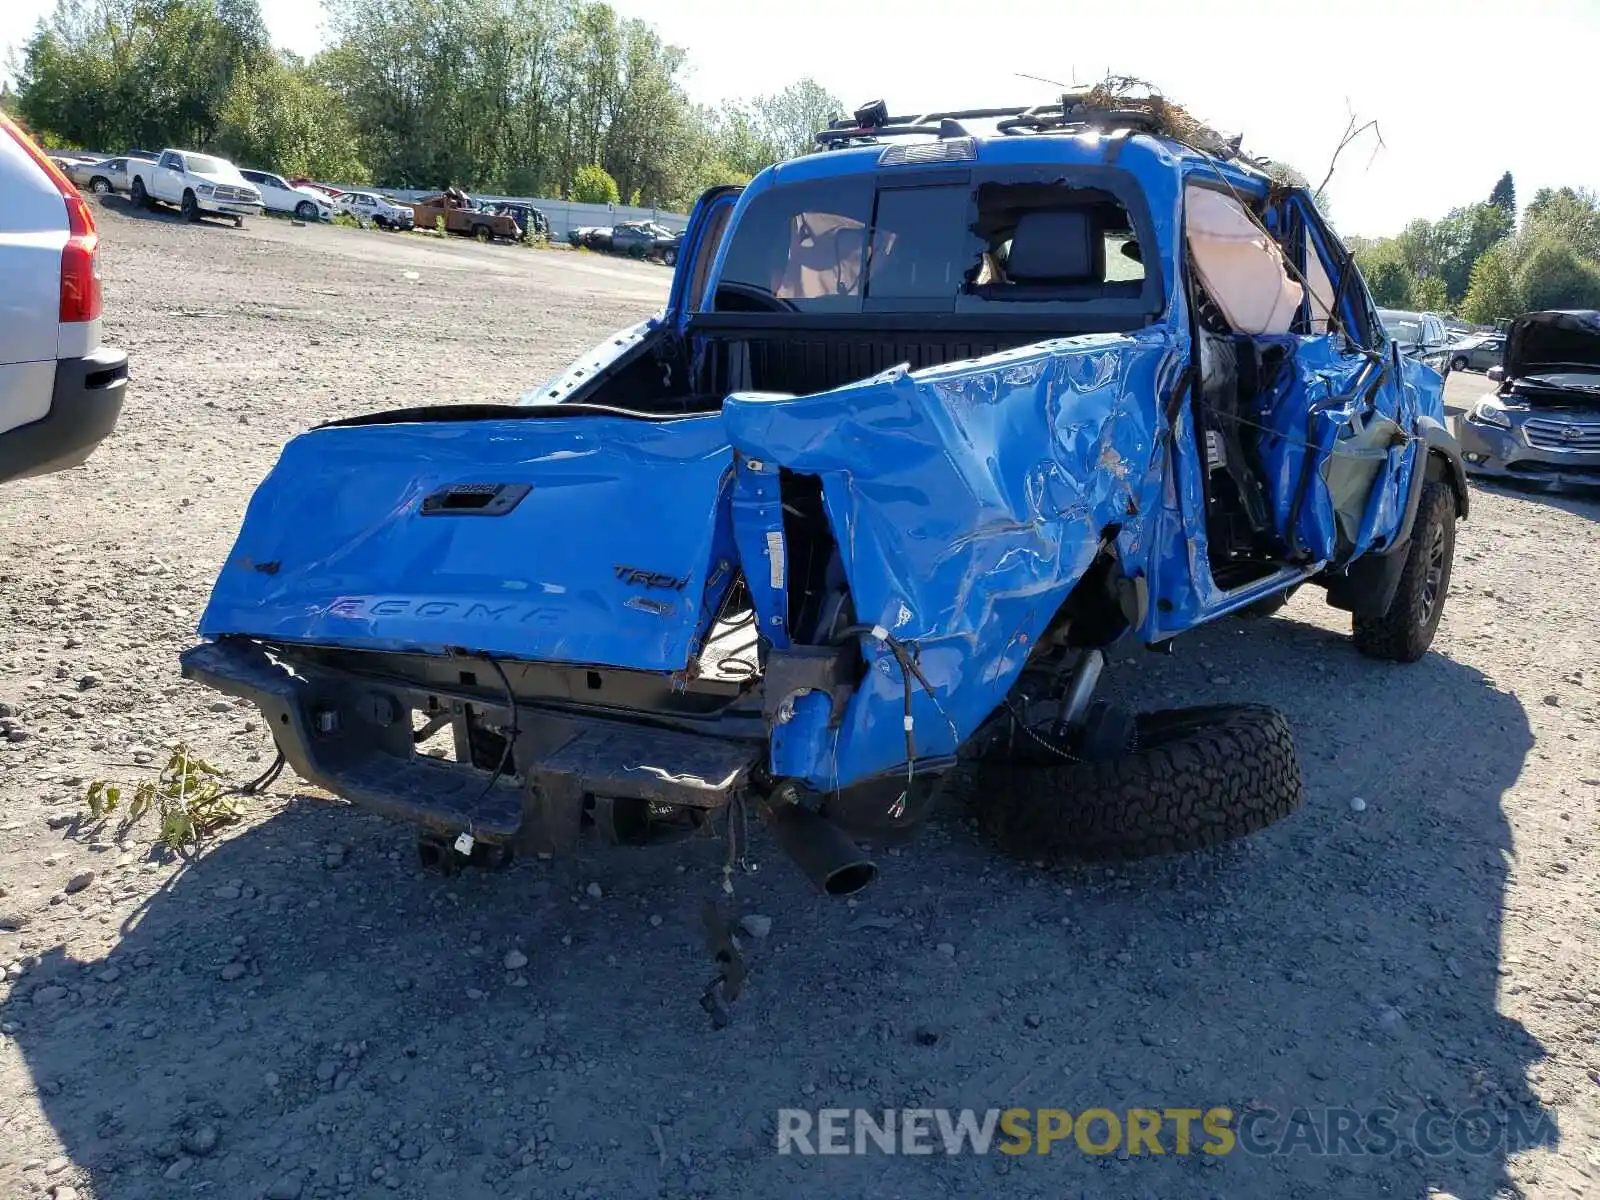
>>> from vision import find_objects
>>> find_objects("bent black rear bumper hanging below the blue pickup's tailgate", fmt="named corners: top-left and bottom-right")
top-left (181, 638), bottom-right (760, 851)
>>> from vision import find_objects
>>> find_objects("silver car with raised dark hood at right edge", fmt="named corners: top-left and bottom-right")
top-left (1461, 310), bottom-right (1600, 486)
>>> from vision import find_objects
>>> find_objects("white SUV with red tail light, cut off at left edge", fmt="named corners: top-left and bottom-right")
top-left (0, 112), bottom-right (128, 482)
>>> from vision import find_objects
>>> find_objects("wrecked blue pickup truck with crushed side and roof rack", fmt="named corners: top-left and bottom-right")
top-left (182, 94), bottom-right (1467, 894)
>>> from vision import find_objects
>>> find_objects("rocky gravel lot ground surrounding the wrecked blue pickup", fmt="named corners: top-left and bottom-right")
top-left (0, 202), bottom-right (1600, 1200)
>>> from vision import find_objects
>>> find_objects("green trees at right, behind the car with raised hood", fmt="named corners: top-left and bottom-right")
top-left (1350, 171), bottom-right (1600, 325)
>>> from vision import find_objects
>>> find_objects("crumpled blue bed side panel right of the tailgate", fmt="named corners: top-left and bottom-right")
top-left (723, 330), bottom-right (1181, 789)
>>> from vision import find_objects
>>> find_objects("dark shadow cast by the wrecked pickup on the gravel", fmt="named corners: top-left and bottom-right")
top-left (9, 614), bottom-right (1558, 1200)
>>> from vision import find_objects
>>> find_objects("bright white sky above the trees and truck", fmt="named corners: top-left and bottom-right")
top-left (0, 0), bottom-right (1600, 235)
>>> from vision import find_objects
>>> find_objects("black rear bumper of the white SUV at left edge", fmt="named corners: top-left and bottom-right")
top-left (0, 346), bottom-right (128, 483)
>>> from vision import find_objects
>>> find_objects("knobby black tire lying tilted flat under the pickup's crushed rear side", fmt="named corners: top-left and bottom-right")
top-left (970, 704), bottom-right (1304, 862)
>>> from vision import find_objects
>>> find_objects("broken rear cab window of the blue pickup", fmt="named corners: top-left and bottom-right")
top-left (712, 166), bottom-right (1162, 328)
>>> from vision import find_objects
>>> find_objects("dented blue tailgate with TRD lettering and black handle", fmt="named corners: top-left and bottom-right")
top-left (198, 416), bottom-right (733, 672)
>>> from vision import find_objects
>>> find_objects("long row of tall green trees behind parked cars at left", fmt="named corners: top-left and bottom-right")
top-left (8, 0), bottom-right (843, 210)
